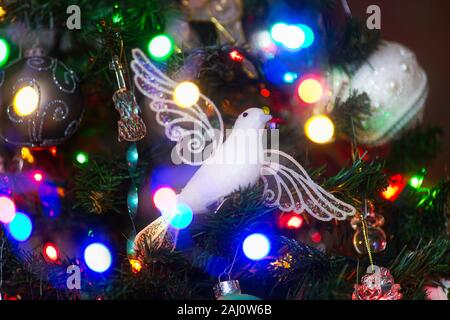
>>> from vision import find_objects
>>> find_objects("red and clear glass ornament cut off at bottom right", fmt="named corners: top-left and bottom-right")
top-left (352, 266), bottom-right (403, 300)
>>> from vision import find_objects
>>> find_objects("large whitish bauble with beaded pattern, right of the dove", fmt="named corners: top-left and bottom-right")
top-left (322, 42), bottom-right (428, 147)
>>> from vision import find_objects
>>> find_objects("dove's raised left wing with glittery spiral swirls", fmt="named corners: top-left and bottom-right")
top-left (131, 49), bottom-right (224, 165)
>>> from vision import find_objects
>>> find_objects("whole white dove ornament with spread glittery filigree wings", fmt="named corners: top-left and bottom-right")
top-left (131, 49), bottom-right (356, 250)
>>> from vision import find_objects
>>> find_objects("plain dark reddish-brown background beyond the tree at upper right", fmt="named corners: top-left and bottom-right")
top-left (348, 0), bottom-right (450, 182)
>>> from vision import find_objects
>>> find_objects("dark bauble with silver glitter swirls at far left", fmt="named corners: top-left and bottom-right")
top-left (0, 49), bottom-right (84, 147)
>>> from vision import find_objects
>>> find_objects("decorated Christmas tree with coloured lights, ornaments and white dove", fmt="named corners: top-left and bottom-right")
top-left (0, 0), bottom-right (450, 300)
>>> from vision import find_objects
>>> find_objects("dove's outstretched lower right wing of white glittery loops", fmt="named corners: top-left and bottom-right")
top-left (261, 150), bottom-right (356, 221)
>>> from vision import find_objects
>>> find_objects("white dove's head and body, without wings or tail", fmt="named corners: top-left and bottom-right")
top-left (178, 108), bottom-right (271, 214)
